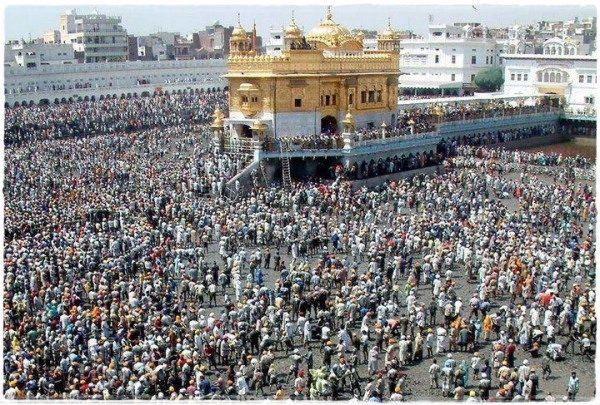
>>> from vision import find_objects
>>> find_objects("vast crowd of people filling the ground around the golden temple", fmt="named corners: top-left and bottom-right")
top-left (3, 95), bottom-right (596, 401)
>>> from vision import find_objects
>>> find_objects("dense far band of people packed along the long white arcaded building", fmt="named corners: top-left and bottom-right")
top-left (4, 91), bottom-right (228, 145)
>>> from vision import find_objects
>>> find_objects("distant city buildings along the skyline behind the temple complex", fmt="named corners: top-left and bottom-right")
top-left (4, 9), bottom-right (596, 68)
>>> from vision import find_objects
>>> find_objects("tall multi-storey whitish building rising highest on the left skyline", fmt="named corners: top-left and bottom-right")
top-left (59, 10), bottom-right (128, 63)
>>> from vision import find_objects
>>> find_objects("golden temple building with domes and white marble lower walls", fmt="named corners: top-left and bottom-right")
top-left (222, 8), bottom-right (399, 139)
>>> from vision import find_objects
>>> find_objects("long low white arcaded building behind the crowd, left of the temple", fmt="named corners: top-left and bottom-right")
top-left (4, 59), bottom-right (227, 106)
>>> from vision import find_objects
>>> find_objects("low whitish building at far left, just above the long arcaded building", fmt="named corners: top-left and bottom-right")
top-left (4, 41), bottom-right (77, 69)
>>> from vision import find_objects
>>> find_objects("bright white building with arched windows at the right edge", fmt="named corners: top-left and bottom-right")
top-left (503, 53), bottom-right (597, 112)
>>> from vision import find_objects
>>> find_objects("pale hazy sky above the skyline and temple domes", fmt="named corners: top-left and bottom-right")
top-left (4, 4), bottom-right (596, 39)
